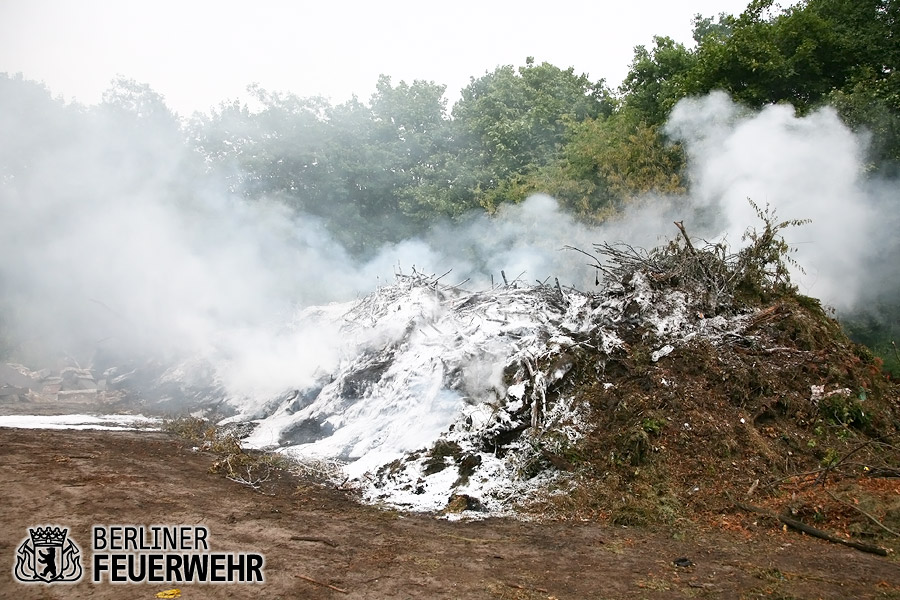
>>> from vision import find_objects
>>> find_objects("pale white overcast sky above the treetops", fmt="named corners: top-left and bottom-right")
top-left (0, 0), bottom-right (747, 115)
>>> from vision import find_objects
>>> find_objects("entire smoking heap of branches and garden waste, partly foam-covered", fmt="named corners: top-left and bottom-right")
top-left (7, 227), bottom-right (900, 524)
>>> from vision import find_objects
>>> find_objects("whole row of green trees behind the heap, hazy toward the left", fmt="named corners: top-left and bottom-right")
top-left (191, 0), bottom-right (900, 251)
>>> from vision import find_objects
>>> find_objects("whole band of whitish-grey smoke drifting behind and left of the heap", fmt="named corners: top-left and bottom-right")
top-left (0, 83), bottom-right (890, 389)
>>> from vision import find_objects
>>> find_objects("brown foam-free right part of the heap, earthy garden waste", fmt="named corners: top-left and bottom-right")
top-left (531, 295), bottom-right (900, 548)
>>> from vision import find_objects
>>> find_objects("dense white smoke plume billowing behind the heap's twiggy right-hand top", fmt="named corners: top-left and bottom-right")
top-left (666, 92), bottom-right (877, 309)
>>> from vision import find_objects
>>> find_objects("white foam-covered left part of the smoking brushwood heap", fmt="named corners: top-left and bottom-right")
top-left (199, 256), bottom-right (749, 512)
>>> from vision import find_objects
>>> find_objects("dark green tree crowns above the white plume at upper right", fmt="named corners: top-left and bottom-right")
top-left (621, 0), bottom-right (900, 163)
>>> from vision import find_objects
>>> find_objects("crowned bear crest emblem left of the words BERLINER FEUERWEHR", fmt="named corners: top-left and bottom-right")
top-left (13, 526), bottom-right (81, 583)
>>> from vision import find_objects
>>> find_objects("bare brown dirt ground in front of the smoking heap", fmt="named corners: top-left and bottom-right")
top-left (0, 429), bottom-right (900, 599)
